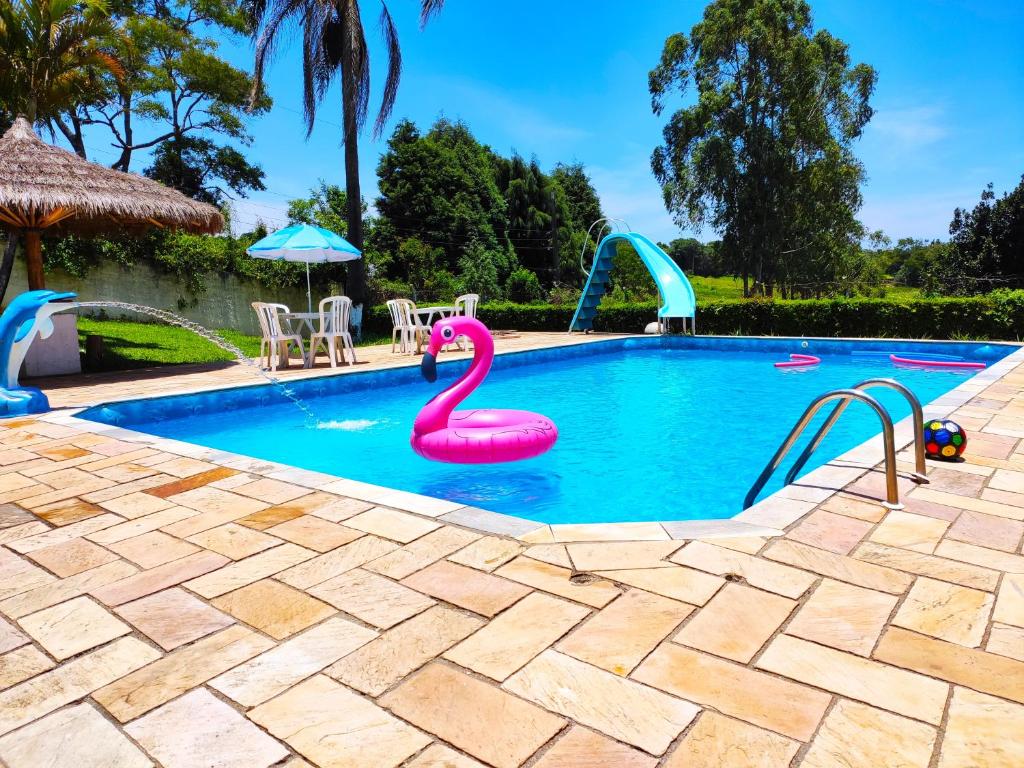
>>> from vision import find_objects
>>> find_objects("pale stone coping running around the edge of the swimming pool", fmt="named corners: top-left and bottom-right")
top-left (49, 334), bottom-right (1024, 544)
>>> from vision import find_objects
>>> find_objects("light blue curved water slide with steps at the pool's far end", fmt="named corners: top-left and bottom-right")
top-left (569, 232), bottom-right (697, 331)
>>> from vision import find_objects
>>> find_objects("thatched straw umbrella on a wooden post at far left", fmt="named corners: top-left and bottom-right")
top-left (0, 117), bottom-right (224, 290)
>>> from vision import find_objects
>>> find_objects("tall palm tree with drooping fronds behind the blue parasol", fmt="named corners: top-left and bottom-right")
top-left (243, 0), bottom-right (444, 304)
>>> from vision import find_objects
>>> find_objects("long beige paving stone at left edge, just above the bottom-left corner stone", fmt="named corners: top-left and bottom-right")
top-left (0, 637), bottom-right (160, 735)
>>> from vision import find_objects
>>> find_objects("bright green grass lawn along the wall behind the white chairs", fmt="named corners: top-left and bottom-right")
top-left (78, 317), bottom-right (382, 371)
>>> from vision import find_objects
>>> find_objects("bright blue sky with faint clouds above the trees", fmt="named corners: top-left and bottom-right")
top-left (88, 0), bottom-right (1024, 240)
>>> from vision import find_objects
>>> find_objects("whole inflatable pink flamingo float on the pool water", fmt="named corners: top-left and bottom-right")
top-left (409, 317), bottom-right (558, 464)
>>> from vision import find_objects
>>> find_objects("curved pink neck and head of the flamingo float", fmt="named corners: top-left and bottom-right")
top-left (413, 317), bottom-right (495, 435)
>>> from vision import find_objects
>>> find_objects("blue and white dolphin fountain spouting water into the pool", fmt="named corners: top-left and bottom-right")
top-left (0, 291), bottom-right (75, 417)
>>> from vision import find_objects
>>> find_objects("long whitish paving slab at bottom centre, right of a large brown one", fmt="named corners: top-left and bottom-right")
top-left (502, 649), bottom-right (698, 755)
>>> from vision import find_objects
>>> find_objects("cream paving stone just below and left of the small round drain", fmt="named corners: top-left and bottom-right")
top-left (444, 592), bottom-right (590, 681)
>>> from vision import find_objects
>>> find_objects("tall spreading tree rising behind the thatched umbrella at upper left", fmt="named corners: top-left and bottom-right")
top-left (53, 0), bottom-right (270, 203)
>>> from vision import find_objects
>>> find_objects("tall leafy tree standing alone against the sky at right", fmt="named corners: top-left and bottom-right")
top-left (649, 0), bottom-right (877, 294)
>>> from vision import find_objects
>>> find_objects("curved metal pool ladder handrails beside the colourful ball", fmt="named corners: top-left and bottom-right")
top-left (743, 379), bottom-right (928, 509)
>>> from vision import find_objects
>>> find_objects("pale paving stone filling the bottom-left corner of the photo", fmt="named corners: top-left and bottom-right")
top-left (0, 703), bottom-right (153, 768)
